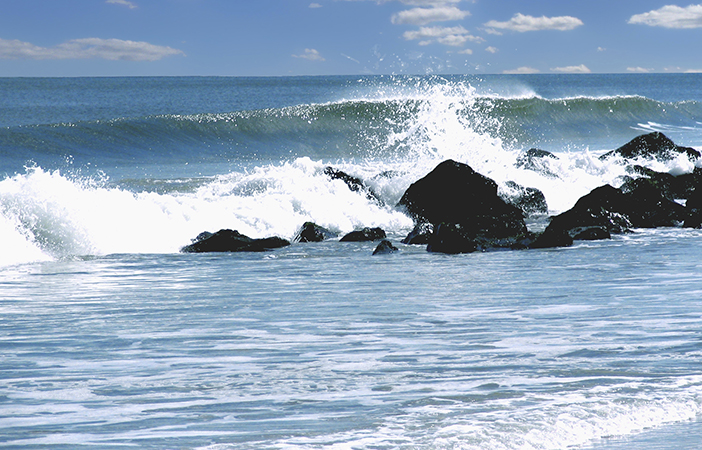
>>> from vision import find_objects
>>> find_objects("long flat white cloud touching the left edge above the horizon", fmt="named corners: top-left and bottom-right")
top-left (0, 38), bottom-right (185, 61)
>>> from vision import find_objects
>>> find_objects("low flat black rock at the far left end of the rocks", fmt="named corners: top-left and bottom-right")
top-left (180, 230), bottom-right (290, 253)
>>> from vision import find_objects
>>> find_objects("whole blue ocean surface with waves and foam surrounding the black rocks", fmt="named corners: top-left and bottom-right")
top-left (0, 74), bottom-right (702, 450)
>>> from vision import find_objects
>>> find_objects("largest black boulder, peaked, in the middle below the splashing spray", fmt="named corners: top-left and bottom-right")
top-left (398, 160), bottom-right (527, 238)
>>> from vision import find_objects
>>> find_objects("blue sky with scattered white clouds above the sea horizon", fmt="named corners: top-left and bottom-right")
top-left (0, 0), bottom-right (702, 77)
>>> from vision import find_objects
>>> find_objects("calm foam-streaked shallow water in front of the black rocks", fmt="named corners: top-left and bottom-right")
top-left (0, 230), bottom-right (702, 449)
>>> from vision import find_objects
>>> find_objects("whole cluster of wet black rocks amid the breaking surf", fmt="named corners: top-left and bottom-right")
top-left (181, 133), bottom-right (702, 255)
